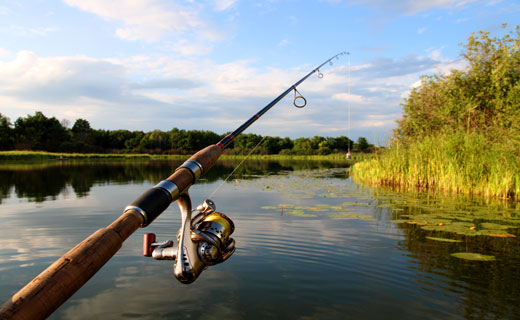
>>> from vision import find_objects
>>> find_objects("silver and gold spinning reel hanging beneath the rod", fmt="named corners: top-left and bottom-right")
top-left (143, 192), bottom-right (235, 284)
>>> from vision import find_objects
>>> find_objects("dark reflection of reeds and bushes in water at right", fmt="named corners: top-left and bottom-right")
top-left (366, 190), bottom-right (520, 319)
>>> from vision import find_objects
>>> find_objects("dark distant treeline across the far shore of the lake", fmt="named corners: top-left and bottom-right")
top-left (0, 112), bottom-right (375, 155)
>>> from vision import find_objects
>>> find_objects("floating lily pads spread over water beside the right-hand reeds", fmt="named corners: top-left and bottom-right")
top-left (256, 168), bottom-right (520, 248)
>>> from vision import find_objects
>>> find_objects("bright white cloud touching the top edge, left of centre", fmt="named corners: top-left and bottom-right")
top-left (64, 0), bottom-right (204, 41)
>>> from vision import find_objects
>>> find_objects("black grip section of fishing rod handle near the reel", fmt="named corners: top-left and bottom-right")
top-left (127, 188), bottom-right (172, 227)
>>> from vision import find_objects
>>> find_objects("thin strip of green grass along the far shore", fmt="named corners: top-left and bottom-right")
top-left (0, 151), bottom-right (371, 163)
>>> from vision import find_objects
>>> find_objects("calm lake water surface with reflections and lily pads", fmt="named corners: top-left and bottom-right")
top-left (0, 161), bottom-right (520, 319)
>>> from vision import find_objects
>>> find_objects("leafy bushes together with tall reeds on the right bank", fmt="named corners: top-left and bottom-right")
top-left (353, 26), bottom-right (520, 200)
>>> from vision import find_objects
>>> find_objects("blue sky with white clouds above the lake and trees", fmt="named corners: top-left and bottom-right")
top-left (0, 0), bottom-right (520, 145)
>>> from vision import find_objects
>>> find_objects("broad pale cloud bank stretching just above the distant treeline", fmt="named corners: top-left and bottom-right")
top-left (0, 47), bottom-right (460, 140)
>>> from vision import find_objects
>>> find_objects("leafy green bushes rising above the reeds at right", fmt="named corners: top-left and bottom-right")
top-left (395, 26), bottom-right (520, 145)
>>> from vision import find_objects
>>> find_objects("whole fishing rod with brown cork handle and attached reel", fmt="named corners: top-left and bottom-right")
top-left (0, 52), bottom-right (348, 319)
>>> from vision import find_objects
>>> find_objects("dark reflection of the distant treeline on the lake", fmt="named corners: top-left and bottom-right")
top-left (0, 161), bottom-right (350, 203)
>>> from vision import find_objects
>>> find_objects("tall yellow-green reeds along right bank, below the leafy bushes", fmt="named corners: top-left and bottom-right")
top-left (351, 133), bottom-right (520, 201)
